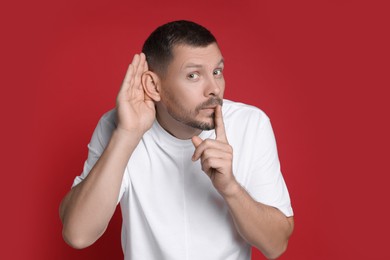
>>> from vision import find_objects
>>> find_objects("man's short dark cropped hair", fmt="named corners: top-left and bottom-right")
top-left (142, 20), bottom-right (217, 76)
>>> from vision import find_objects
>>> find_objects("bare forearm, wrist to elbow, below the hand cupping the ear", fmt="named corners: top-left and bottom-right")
top-left (60, 129), bottom-right (141, 248)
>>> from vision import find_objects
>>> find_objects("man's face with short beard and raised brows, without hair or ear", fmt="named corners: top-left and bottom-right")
top-left (161, 43), bottom-right (225, 130)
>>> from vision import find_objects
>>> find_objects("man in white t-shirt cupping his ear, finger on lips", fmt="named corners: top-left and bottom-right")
top-left (60, 21), bottom-right (293, 260)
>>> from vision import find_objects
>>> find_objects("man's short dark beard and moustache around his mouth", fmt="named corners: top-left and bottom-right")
top-left (161, 93), bottom-right (223, 130)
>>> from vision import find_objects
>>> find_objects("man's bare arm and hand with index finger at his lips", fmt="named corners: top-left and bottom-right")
top-left (192, 106), bottom-right (294, 259)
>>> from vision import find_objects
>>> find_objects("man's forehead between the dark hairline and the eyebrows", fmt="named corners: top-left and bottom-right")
top-left (170, 43), bottom-right (223, 69)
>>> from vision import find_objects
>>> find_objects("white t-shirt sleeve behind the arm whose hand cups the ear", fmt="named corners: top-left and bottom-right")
top-left (72, 110), bottom-right (127, 203)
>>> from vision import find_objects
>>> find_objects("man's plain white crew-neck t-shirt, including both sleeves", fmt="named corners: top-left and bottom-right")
top-left (73, 100), bottom-right (293, 260)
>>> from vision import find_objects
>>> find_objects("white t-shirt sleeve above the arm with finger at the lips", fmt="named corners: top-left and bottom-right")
top-left (246, 114), bottom-right (293, 217)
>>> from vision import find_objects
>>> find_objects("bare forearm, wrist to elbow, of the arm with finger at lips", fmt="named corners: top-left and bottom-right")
top-left (224, 183), bottom-right (294, 259)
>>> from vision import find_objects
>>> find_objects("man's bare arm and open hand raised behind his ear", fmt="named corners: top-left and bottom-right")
top-left (60, 54), bottom-right (155, 248)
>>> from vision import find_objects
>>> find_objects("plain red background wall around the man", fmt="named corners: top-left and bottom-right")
top-left (0, 0), bottom-right (390, 260)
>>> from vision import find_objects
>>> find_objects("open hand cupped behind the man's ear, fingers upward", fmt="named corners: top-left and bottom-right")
top-left (116, 53), bottom-right (156, 136)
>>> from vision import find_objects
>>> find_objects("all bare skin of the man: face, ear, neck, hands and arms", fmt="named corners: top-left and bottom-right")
top-left (60, 44), bottom-right (294, 258)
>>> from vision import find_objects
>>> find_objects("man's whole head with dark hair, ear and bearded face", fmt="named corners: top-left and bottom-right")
top-left (142, 21), bottom-right (225, 139)
